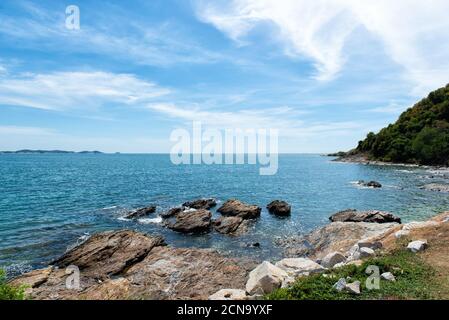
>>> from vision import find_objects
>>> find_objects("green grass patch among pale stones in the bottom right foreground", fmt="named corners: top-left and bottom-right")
top-left (265, 249), bottom-right (440, 300)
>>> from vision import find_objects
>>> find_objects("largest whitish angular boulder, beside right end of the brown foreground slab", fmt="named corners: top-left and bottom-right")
top-left (246, 261), bottom-right (288, 295)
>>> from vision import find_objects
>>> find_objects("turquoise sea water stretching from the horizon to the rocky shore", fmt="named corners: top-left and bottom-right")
top-left (0, 154), bottom-right (449, 273)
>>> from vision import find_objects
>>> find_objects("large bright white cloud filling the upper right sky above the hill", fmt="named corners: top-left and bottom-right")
top-left (196, 0), bottom-right (449, 90)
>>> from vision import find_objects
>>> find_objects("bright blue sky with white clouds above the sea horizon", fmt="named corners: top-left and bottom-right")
top-left (0, 0), bottom-right (449, 153)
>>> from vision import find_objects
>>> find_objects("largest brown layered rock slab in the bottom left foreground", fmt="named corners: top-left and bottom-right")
top-left (11, 231), bottom-right (255, 300)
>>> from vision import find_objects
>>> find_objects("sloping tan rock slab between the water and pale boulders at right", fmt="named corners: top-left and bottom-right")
top-left (276, 222), bottom-right (397, 260)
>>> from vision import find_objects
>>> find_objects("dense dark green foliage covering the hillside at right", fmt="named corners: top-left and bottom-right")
top-left (355, 84), bottom-right (449, 165)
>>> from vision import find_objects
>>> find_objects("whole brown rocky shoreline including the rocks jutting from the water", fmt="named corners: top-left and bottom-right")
top-left (10, 200), bottom-right (449, 300)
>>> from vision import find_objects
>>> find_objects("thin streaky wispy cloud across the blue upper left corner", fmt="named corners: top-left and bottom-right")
top-left (0, 2), bottom-right (222, 66)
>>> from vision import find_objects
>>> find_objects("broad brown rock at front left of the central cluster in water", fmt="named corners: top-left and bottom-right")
top-left (167, 209), bottom-right (212, 233)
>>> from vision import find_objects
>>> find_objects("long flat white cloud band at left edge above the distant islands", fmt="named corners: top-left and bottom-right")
top-left (0, 71), bottom-right (170, 110)
